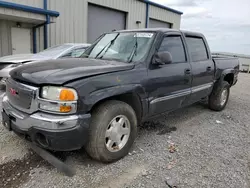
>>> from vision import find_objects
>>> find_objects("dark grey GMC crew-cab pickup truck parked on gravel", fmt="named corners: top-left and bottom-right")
top-left (2, 29), bottom-right (239, 162)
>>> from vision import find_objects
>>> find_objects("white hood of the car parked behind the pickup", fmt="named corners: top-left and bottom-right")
top-left (0, 54), bottom-right (51, 64)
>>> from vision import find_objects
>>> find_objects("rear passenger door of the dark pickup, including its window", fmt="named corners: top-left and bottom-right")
top-left (186, 35), bottom-right (215, 103)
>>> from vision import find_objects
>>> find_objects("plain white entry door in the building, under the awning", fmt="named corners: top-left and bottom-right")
top-left (11, 27), bottom-right (31, 55)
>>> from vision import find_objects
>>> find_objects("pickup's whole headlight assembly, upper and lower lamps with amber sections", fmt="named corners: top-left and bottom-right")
top-left (39, 86), bottom-right (78, 113)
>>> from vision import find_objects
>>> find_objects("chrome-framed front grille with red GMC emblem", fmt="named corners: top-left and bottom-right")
top-left (6, 78), bottom-right (38, 113)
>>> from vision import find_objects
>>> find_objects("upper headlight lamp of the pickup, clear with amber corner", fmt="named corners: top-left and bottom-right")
top-left (41, 86), bottom-right (78, 101)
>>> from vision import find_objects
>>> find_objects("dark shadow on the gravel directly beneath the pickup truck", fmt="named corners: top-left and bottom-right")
top-left (50, 103), bottom-right (211, 166)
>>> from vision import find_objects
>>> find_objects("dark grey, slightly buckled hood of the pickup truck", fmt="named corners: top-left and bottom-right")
top-left (10, 58), bottom-right (134, 85)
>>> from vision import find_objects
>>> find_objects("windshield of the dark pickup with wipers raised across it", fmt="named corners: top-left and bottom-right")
top-left (82, 32), bottom-right (154, 62)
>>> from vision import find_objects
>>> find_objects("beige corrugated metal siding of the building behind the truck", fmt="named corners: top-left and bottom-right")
top-left (0, 0), bottom-right (181, 56)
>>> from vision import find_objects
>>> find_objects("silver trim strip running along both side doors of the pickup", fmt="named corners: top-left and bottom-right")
top-left (150, 82), bottom-right (213, 104)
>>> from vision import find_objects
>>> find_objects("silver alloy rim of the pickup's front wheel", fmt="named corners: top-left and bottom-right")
top-left (105, 115), bottom-right (130, 152)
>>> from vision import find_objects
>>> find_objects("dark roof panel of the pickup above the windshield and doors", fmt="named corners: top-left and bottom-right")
top-left (114, 28), bottom-right (203, 37)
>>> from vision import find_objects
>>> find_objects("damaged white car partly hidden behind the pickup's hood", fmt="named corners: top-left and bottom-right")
top-left (0, 43), bottom-right (90, 85)
